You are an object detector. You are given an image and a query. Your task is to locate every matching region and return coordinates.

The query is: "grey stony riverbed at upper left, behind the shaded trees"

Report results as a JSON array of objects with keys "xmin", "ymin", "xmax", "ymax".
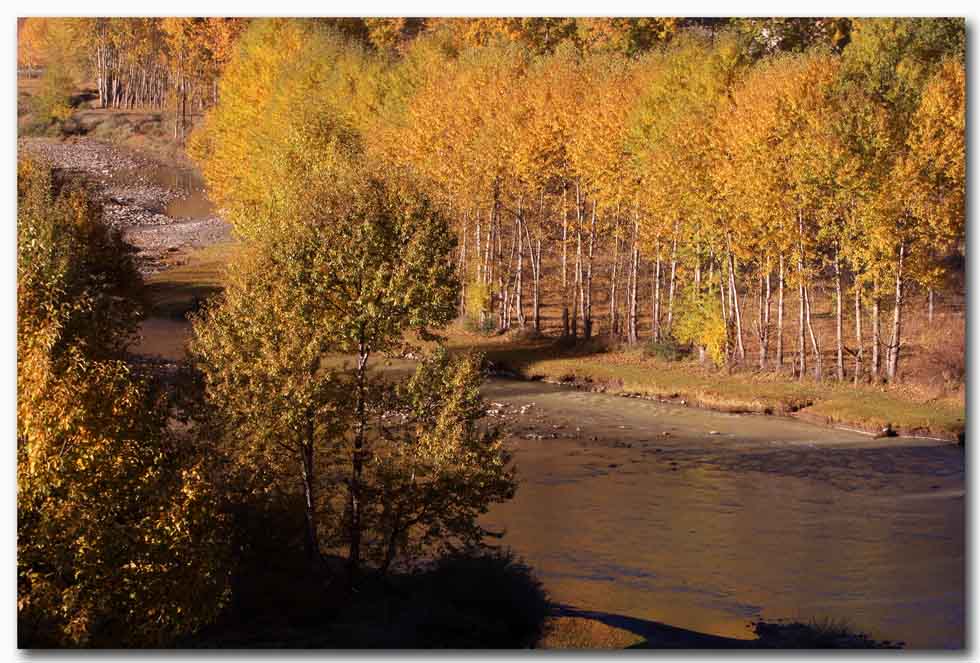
[{"xmin": 18, "ymin": 138, "xmax": 231, "ymax": 277}]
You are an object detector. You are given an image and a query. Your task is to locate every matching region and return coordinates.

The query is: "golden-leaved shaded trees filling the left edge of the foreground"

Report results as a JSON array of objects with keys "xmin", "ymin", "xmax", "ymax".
[{"xmin": 17, "ymin": 161, "xmax": 229, "ymax": 647}]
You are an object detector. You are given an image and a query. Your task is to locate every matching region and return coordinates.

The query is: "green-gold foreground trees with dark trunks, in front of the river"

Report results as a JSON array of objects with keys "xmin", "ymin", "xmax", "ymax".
[{"xmin": 192, "ymin": 166, "xmax": 513, "ymax": 581}]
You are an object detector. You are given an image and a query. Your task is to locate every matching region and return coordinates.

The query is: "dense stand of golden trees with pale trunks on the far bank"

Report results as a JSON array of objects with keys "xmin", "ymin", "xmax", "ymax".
[{"xmin": 188, "ymin": 18, "xmax": 965, "ymax": 381}]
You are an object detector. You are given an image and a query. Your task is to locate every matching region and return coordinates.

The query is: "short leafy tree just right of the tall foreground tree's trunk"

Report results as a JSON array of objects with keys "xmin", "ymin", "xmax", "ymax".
[{"xmin": 363, "ymin": 347, "xmax": 516, "ymax": 572}]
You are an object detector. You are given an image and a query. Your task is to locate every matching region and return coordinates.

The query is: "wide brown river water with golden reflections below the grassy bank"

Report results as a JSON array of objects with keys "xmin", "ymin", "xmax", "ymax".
[{"xmin": 485, "ymin": 381, "xmax": 965, "ymax": 647}]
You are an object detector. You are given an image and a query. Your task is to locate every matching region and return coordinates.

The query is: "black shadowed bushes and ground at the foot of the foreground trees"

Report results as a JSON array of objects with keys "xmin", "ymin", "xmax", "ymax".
[{"xmin": 183, "ymin": 503, "xmax": 550, "ymax": 649}]
